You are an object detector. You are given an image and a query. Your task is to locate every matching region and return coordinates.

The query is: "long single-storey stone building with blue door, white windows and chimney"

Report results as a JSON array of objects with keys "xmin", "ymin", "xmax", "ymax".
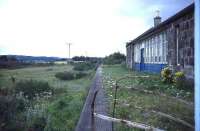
[{"xmin": 126, "ymin": 3, "xmax": 194, "ymax": 79}]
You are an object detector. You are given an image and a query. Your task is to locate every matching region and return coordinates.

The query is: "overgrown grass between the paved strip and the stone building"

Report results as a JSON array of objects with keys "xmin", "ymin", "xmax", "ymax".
[{"xmin": 103, "ymin": 65, "xmax": 194, "ymax": 131}]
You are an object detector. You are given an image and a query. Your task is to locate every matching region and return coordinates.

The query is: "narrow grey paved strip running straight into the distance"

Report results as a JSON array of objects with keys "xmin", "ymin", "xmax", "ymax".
[{"xmin": 75, "ymin": 67, "xmax": 112, "ymax": 131}]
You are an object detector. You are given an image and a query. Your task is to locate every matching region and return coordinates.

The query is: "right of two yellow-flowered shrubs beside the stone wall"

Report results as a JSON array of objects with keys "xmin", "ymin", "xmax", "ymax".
[{"xmin": 173, "ymin": 71, "xmax": 186, "ymax": 88}]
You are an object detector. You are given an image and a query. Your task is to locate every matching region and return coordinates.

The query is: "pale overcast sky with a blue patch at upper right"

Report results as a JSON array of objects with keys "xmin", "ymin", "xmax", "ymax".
[{"xmin": 0, "ymin": 0, "xmax": 193, "ymax": 57}]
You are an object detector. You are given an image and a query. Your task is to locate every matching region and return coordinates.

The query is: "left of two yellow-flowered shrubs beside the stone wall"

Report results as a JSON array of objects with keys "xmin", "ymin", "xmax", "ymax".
[{"xmin": 161, "ymin": 67, "xmax": 173, "ymax": 83}]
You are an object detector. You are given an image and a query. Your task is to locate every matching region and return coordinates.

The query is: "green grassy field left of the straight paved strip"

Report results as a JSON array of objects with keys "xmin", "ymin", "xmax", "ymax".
[{"xmin": 0, "ymin": 65, "xmax": 94, "ymax": 131}]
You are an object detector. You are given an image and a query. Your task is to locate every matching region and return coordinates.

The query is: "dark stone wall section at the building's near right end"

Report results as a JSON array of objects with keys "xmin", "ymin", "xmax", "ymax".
[{"xmin": 167, "ymin": 12, "xmax": 194, "ymax": 79}]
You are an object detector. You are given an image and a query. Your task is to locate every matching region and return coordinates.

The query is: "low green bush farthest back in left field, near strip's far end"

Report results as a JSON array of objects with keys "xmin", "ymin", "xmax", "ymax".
[{"xmin": 73, "ymin": 62, "xmax": 95, "ymax": 71}]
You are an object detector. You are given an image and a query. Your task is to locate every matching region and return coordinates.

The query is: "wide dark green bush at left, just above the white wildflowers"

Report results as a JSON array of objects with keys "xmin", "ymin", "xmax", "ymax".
[{"xmin": 15, "ymin": 80, "xmax": 53, "ymax": 100}]
